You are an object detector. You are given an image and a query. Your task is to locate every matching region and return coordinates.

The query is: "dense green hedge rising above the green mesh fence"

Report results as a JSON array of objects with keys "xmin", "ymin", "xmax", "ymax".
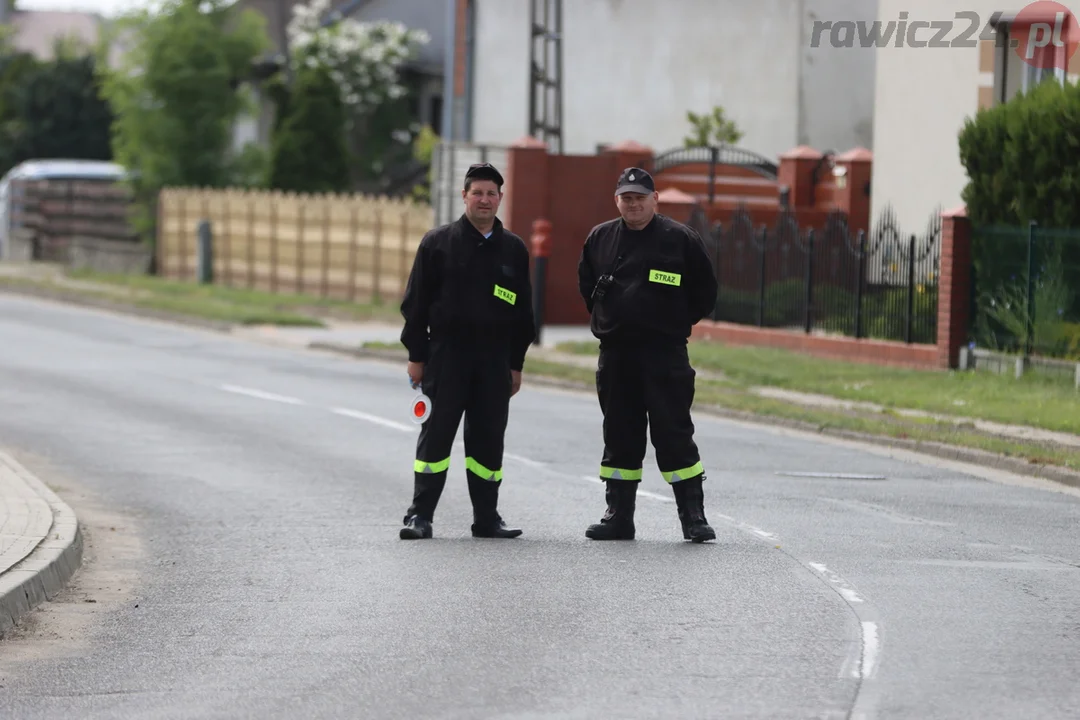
[{"xmin": 959, "ymin": 81, "xmax": 1080, "ymax": 228}]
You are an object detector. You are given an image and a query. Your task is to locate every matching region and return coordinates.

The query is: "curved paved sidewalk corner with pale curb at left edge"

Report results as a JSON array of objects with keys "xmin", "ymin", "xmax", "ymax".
[{"xmin": 0, "ymin": 451, "xmax": 82, "ymax": 633}]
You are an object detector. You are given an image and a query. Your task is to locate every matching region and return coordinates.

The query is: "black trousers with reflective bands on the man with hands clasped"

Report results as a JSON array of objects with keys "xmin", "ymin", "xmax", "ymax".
[{"xmin": 596, "ymin": 340, "xmax": 704, "ymax": 483}]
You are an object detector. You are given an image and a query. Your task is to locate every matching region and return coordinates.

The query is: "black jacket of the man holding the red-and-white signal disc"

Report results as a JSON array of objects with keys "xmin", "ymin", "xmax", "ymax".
[{"xmin": 401, "ymin": 215, "xmax": 536, "ymax": 370}]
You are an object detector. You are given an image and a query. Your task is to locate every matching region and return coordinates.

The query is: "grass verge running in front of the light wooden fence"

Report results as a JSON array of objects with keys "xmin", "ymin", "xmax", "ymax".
[{"xmin": 0, "ymin": 271, "xmax": 399, "ymax": 327}]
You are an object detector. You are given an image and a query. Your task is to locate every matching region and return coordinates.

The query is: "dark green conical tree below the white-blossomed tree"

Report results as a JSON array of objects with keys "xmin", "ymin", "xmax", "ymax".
[{"xmin": 270, "ymin": 66, "xmax": 349, "ymax": 192}]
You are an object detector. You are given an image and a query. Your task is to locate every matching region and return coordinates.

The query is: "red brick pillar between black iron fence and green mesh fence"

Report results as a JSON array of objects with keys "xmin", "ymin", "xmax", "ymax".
[{"xmin": 937, "ymin": 207, "xmax": 971, "ymax": 369}]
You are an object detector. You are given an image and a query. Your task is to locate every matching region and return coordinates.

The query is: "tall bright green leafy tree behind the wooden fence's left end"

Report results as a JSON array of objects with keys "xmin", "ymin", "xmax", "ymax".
[{"xmin": 103, "ymin": 0, "xmax": 269, "ymax": 237}]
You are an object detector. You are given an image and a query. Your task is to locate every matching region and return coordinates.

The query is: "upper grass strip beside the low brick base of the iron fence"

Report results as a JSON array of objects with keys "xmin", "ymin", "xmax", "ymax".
[{"xmin": 558, "ymin": 342, "xmax": 1080, "ymax": 434}]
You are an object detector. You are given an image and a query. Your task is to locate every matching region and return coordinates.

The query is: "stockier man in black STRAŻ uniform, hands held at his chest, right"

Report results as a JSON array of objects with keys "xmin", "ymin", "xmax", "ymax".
[{"xmin": 578, "ymin": 167, "xmax": 717, "ymax": 542}]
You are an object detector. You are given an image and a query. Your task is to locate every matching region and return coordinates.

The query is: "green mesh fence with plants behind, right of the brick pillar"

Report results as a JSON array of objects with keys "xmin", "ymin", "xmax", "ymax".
[{"xmin": 970, "ymin": 223, "xmax": 1080, "ymax": 359}]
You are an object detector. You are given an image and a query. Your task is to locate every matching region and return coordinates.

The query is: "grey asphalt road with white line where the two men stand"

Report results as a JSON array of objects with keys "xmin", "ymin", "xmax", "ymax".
[{"xmin": 0, "ymin": 295, "xmax": 1080, "ymax": 720}]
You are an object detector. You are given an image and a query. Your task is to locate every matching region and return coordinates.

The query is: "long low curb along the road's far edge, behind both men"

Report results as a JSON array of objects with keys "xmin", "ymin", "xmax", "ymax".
[{"xmin": 308, "ymin": 342, "xmax": 1080, "ymax": 488}]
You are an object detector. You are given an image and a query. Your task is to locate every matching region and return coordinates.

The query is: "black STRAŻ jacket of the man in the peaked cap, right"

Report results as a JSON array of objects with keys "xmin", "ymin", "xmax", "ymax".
[{"xmin": 578, "ymin": 214, "xmax": 717, "ymax": 342}]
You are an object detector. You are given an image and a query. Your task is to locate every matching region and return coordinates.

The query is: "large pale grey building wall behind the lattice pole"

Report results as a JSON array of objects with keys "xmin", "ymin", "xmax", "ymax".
[{"xmin": 472, "ymin": 0, "xmax": 807, "ymax": 155}]
